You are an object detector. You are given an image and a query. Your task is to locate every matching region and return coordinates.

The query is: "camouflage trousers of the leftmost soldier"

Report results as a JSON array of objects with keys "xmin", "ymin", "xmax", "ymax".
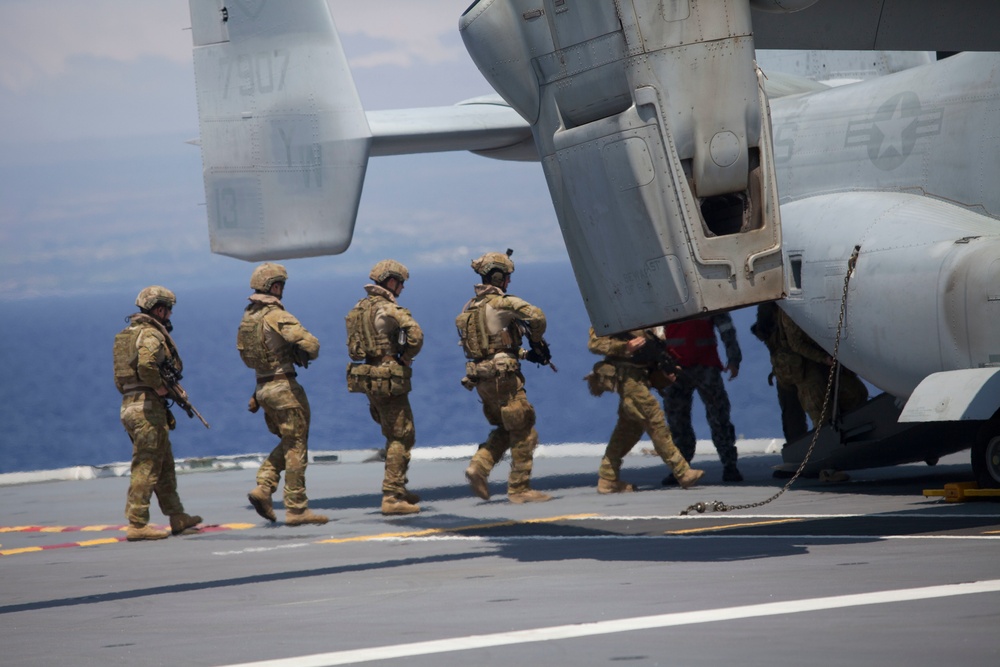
[{"xmin": 121, "ymin": 391, "xmax": 184, "ymax": 526}]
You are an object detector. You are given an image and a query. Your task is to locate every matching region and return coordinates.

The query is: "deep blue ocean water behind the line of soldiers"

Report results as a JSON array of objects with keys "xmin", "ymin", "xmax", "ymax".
[{"xmin": 0, "ymin": 264, "xmax": 781, "ymax": 473}]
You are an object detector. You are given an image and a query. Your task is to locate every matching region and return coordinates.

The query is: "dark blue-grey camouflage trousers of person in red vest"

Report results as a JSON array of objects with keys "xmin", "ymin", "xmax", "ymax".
[{"xmin": 663, "ymin": 366, "xmax": 737, "ymax": 467}]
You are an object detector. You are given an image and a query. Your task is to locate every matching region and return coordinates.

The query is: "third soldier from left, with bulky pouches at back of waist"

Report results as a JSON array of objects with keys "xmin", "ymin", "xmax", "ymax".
[{"xmin": 346, "ymin": 259, "xmax": 424, "ymax": 514}]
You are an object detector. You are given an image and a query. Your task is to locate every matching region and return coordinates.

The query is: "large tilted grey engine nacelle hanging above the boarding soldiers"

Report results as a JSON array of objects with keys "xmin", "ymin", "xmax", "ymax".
[{"xmin": 460, "ymin": 0, "xmax": 785, "ymax": 333}]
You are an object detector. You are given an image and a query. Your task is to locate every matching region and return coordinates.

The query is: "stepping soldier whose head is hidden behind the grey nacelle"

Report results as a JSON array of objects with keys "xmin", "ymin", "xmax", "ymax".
[{"xmin": 587, "ymin": 327, "xmax": 705, "ymax": 493}]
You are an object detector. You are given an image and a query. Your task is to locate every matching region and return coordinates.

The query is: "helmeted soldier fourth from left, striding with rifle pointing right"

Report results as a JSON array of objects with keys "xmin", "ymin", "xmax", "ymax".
[{"xmin": 455, "ymin": 251, "xmax": 551, "ymax": 503}]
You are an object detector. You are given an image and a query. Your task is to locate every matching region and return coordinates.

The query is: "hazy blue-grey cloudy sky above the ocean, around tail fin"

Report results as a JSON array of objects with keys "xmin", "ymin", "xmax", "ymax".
[{"xmin": 0, "ymin": 0, "xmax": 567, "ymax": 300}]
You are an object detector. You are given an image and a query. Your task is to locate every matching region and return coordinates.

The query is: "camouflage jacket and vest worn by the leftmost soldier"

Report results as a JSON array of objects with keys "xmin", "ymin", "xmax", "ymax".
[{"xmin": 115, "ymin": 313, "xmax": 184, "ymax": 394}]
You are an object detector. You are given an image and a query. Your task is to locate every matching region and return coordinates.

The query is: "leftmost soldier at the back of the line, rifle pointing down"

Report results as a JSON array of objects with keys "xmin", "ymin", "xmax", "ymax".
[{"xmin": 114, "ymin": 285, "xmax": 201, "ymax": 542}]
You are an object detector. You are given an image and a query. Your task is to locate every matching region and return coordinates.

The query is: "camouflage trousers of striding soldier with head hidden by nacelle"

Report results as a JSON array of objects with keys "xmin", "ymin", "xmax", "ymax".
[{"xmin": 597, "ymin": 367, "xmax": 689, "ymax": 482}]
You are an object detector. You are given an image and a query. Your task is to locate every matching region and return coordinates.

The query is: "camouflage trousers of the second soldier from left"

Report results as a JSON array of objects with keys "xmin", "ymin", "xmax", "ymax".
[{"xmin": 256, "ymin": 378, "xmax": 310, "ymax": 510}]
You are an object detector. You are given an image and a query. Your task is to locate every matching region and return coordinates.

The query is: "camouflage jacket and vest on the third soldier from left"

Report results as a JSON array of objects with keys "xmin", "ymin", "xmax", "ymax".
[{"xmin": 348, "ymin": 285, "xmax": 424, "ymax": 366}]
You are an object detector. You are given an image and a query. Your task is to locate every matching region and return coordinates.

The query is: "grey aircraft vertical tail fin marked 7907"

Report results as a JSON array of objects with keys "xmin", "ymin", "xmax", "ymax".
[{"xmin": 190, "ymin": 0, "xmax": 371, "ymax": 261}]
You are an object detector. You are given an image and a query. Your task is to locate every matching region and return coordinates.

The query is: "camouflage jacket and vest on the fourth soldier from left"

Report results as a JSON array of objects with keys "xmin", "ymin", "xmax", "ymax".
[{"xmin": 456, "ymin": 284, "xmax": 546, "ymax": 362}]
